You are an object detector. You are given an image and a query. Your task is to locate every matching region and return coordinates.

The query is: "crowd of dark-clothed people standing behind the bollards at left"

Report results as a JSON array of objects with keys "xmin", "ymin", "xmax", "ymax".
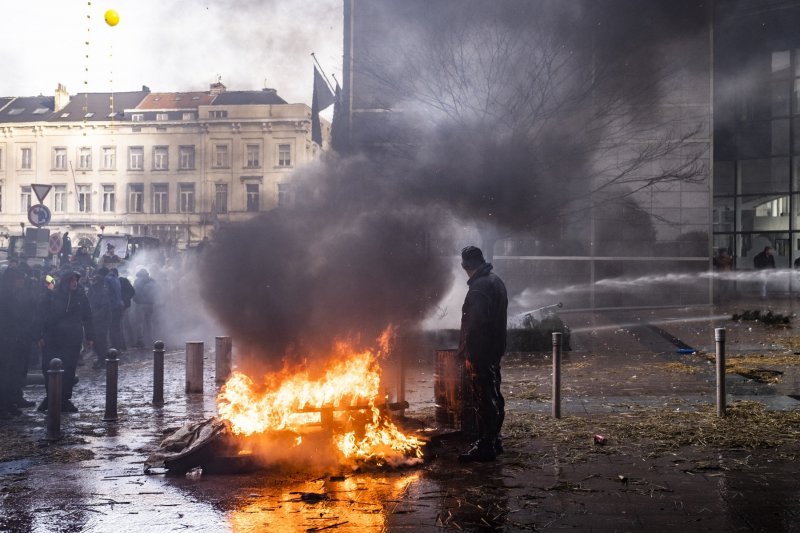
[{"xmin": 0, "ymin": 246, "xmax": 164, "ymax": 418}]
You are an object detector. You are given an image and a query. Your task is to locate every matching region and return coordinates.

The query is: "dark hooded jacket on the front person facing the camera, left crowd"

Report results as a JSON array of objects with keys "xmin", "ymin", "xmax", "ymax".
[{"xmin": 43, "ymin": 273, "xmax": 94, "ymax": 345}]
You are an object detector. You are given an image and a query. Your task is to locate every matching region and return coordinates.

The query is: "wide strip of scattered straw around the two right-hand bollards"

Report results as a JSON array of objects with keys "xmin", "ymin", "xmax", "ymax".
[{"xmin": 503, "ymin": 401, "xmax": 800, "ymax": 462}]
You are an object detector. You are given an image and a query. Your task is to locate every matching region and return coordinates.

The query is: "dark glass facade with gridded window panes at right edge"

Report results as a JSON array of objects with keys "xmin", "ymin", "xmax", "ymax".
[{"xmin": 712, "ymin": 0, "xmax": 800, "ymax": 278}]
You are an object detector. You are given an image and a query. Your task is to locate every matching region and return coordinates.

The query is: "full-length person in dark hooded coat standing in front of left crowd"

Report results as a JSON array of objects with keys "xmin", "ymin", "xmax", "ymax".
[{"xmin": 38, "ymin": 272, "xmax": 94, "ymax": 413}]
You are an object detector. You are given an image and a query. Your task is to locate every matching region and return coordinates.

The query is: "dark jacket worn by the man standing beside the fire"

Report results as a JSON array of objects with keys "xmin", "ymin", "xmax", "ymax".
[{"xmin": 459, "ymin": 263, "xmax": 508, "ymax": 365}]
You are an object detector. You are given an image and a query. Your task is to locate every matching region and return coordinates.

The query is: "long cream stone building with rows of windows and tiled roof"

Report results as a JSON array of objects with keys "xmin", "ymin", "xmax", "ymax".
[{"xmin": 0, "ymin": 82, "xmax": 330, "ymax": 248}]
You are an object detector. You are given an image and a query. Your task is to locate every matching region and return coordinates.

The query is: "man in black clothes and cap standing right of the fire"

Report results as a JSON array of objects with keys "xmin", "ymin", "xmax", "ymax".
[{"xmin": 458, "ymin": 246, "xmax": 508, "ymax": 462}]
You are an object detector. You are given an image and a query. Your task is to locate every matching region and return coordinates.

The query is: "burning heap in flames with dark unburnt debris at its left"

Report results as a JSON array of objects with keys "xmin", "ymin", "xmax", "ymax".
[{"xmin": 146, "ymin": 338, "xmax": 425, "ymax": 472}]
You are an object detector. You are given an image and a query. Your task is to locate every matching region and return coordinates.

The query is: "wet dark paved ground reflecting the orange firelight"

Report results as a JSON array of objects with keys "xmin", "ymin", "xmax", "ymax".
[{"xmin": 0, "ymin": 300, "xmax": 800, "ymax": 532}]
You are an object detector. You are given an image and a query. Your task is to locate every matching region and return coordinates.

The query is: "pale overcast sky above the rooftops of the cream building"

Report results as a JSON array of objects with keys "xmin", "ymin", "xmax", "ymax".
[{"xmin": 0, "ymin": 0, "xmax": 342, "ymax": 105}]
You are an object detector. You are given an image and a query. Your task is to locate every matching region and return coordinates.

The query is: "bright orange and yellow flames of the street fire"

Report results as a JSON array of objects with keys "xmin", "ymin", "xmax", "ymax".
[{"xmin": 217, "ymin": 335, "xmax": 423, "ymax": 464}]
